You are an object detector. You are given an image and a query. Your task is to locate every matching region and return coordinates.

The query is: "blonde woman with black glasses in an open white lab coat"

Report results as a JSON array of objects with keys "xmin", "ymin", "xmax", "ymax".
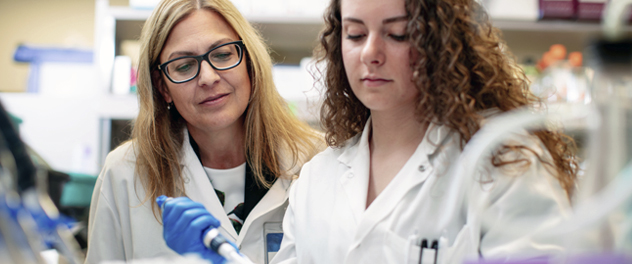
[{"xmin": 86, "ymin": 0, "xmax": 320, "ymax": 263}]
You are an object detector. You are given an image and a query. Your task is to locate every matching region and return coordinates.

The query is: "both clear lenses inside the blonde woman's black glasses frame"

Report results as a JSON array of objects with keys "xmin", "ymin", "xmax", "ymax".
[{"xmin": 166, "ymin": 44, "xmax": 241, "ymax": 82}]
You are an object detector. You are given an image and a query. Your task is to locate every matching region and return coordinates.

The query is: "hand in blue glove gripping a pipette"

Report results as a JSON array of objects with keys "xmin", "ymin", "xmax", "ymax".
[{"xmin": 156, "ymin": 195, "xmax": 237, "ymax": 264}]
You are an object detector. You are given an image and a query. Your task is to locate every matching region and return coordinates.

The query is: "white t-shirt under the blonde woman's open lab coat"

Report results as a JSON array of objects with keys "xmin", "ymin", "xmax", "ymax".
[{"xmin": 204, "ymin": 162, "xmax": 246, "ymax": 214}]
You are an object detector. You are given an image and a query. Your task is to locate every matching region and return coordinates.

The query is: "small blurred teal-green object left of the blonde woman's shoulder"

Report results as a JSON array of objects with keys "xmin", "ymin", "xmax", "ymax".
[{"xmin": 59, "ymin": 173, "xmax": 97, "ymax": 207}]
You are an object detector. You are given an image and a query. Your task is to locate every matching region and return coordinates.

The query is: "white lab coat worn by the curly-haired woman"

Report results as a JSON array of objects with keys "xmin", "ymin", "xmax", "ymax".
[{"xmin": 272, "ymin": 117, "xmax": 570, "ymax": 264}]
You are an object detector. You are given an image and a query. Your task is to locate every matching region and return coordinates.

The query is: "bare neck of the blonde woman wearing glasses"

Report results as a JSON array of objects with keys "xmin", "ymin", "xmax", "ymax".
[{"xmin": 189, "ymin": 122, "xmax": 246, "ymax": 169}]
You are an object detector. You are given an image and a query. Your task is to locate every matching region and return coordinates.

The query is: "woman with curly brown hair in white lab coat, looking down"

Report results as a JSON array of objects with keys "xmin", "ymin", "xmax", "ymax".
[{"xmin": 273, "ymin": 0, "xmax": 577, "ymax": 263}]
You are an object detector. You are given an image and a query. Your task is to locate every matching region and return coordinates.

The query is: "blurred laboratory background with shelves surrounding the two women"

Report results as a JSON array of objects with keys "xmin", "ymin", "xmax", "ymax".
[{"xmin": 0, "ymin": 0, "xmax": 632, "ymax": 263}]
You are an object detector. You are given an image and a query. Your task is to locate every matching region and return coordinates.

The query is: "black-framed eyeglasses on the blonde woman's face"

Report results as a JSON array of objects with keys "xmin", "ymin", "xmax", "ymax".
[{"xmin": 158, "ymin": 40, "xmax": 246, "ymax": 83}]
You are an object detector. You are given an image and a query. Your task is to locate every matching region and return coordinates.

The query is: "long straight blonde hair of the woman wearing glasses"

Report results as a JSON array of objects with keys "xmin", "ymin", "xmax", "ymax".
[{"xmin": 132, "ymin": 0, "xmax": 318, "ymax": 219}]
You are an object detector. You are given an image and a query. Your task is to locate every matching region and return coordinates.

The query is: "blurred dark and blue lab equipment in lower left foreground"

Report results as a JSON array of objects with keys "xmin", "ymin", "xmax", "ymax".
[{"xmin": 0, "ymin": 100, "xmax": 82, "ymax": 264}]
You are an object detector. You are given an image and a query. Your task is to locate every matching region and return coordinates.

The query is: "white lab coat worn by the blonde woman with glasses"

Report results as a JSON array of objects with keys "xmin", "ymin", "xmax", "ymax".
[{"xmin": 86, "ymin": 131, "xmax": 300, "ymax": 263}]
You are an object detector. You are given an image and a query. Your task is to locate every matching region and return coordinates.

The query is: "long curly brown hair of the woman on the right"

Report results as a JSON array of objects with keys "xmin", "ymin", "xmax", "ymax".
[{"xmin": 316, "ymin": 0, "xmax": 578, "ymax": 197}]
